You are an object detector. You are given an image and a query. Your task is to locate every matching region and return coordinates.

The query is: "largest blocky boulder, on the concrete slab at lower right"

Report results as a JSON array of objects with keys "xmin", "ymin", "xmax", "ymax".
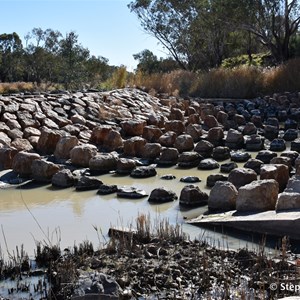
[{"xmin": 236, "ymin": 179, "xmax": 279, "ymax": 212}]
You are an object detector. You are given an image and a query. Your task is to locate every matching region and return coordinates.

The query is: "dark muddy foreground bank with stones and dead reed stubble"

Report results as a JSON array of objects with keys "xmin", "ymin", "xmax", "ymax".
[{"xmin": 0, "ymin": 215, "xmax": 299, "ymax": 299}]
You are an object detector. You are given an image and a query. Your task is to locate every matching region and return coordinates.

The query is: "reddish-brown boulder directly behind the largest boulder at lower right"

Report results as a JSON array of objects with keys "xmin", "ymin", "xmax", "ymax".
[{"xmin": 260, "ymin": 164, "xmax": 289, "ymax": 192}]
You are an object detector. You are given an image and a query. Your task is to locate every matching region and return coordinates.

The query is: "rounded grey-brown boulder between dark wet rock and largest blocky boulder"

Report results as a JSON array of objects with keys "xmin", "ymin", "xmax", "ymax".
[{"xmin": 208, "ymin": 181, "xmax": 238, "ymax": 211}]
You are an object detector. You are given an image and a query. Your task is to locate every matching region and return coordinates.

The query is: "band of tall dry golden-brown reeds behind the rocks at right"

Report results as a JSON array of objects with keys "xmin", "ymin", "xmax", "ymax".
[{"xmin": 129, "ymin": 58, "xmax": 300, "ymax": 98}]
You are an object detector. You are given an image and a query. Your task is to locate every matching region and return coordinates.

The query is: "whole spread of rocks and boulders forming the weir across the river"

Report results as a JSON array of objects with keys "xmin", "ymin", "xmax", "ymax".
[{"xmin": 0, "ymin": 88, "xmax": 300, "ymax": 211}]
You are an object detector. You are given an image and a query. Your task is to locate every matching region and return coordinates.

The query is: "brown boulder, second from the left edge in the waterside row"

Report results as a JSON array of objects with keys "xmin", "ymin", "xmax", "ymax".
[{"xmin": 12, "ymin": 151, "xmax": 41, "ymax": 177}]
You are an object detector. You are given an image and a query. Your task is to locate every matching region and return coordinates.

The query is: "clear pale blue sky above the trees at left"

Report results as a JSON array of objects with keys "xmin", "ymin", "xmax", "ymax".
[{"xmin": 0, "ymin": 0, "xmax": 166, "ymax": 70}]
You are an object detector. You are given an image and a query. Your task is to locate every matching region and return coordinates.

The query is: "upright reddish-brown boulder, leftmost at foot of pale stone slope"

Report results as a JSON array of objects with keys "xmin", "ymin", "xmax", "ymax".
[{"xmin": 37, "ymin": 127, "xmax": 62, "ymax": 154}]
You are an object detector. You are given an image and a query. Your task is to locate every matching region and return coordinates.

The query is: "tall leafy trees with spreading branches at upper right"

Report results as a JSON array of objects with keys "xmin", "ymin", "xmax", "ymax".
[{"xmin": 128, "ymin": 0, "xmax": 300, "ymax": 71}]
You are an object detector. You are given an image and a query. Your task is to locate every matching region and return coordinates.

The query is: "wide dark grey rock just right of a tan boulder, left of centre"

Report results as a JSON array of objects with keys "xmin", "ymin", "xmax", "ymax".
[{"xmin": 89, "ymin": 153, "xmax": 118, "ymax": 173}]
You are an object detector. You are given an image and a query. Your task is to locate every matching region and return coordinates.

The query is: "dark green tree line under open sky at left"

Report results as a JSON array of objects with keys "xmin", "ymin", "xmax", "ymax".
[{"xmin": 0, "ymin": 28, "xmax": 116, "ymax": 89}]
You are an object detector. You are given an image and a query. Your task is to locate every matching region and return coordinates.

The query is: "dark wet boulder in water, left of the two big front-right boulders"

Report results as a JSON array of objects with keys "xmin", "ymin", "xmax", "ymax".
[{"xmin": 179, "ymin": 185, "xmax": 208, "ymax": 207}]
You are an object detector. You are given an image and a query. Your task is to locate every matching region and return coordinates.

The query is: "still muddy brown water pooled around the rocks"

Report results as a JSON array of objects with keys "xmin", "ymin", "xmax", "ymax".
[{"xmin": 0, "ymin": 157, "xmax": 284, "ymax": 255}]
